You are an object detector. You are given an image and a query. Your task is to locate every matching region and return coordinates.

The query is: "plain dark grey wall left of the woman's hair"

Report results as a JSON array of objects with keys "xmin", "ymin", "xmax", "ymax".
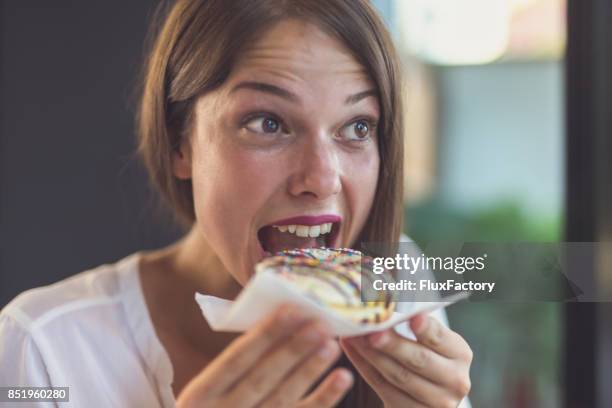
[{"xmin": 0, "ymin": 0, "xmax": 178, "ymax": 308}]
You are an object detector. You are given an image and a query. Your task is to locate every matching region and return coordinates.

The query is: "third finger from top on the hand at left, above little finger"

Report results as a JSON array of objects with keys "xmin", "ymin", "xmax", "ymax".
[{"xmin": 262, "ymin": 340, "xmax": 340, "ymax": 407}]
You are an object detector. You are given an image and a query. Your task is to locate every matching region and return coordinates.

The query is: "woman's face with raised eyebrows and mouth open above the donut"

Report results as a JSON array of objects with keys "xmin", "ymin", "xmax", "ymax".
[{"xmin": 174, "ymin": 20, "xmax": 380, "ymax": 285}]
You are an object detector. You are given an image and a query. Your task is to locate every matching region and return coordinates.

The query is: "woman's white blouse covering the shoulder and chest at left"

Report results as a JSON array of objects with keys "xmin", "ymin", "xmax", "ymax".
[{"xmin": 0, "ymin": 252, "xmax": 469, "ymax": 408}]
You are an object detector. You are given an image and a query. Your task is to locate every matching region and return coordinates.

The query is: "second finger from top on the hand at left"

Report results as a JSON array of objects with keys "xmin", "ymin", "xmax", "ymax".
[{"xmin": 227, "ymin": 322, "xmax": 330, "ymax": 406}]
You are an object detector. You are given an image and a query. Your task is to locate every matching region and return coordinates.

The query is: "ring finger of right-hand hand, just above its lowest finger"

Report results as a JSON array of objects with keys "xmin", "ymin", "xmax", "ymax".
[{"xmin": 351, "ymin": 340, "xmax": 456, "ymax": 407}]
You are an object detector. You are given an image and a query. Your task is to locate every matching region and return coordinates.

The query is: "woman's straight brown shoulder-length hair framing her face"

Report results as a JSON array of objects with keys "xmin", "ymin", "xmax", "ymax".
[{"xmin": 137, "ymin": 0, "xmax": 403, "ymax": 406}]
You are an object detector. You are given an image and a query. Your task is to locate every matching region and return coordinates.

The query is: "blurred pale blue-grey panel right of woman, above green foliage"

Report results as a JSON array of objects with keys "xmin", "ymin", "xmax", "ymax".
[{"xmin": 438, "ymin": 61, "xmax": 565, "ymax": 217}]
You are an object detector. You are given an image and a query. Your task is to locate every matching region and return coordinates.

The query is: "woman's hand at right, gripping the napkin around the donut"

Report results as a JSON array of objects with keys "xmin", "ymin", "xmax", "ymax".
[{"xmin": 340, "ymin": 315, "xmax": 472, "ymax": 408}]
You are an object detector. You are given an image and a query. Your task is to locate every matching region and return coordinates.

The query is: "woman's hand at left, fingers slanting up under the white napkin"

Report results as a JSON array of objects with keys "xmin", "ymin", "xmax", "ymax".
[{"xmin": 177, "ymin": 306, "xmax": 353, "ymax": 408}]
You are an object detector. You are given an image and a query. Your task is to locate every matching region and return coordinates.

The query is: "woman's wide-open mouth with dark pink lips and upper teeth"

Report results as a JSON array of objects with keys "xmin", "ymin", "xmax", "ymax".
[{"xmin": 257, "ymin": 216, "xmax": 340, "ymax": 254}]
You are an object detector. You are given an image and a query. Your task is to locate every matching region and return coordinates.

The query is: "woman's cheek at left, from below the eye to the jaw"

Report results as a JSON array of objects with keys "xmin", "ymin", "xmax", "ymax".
[{"xmin": 192, "ymin": 139, "xmax": 283, "ymax": 284}]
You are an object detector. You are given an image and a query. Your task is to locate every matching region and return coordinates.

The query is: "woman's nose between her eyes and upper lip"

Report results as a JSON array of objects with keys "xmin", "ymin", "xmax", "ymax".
[{"xmin": 289, "ymin": 135, "xmax": 341, "ymax": 200}]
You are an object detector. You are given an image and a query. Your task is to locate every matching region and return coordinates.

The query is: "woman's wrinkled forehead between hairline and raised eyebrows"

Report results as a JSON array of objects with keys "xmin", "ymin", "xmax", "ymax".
[{"xmin": 229, "ymin": 19, "xmax": 373, "ymax": 91}]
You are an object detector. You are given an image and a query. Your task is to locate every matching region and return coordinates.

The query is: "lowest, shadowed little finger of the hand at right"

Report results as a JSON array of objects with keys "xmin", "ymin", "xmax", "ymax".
[{"xmin": 340, "ymin": 339, "xmax": 426, "ymax": 408}]
